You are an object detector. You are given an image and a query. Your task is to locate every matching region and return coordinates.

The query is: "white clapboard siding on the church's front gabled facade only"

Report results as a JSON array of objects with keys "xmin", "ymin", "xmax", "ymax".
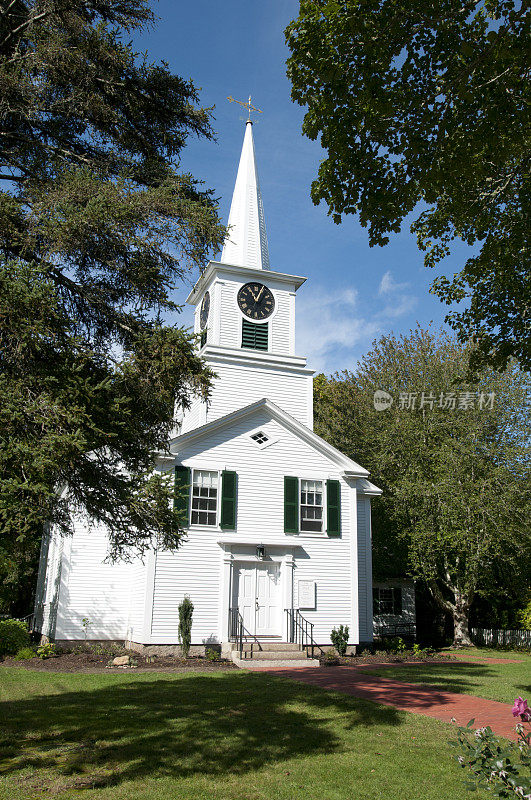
[{"xmin": 166, "ymin": 413, "xmax": 355, "ymax": 644}]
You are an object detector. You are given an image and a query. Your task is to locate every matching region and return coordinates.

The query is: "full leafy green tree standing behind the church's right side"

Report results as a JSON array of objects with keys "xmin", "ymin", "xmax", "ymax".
[{"xmin": 315, "ymin": 330, "xmax": 531, "ymax": 644}]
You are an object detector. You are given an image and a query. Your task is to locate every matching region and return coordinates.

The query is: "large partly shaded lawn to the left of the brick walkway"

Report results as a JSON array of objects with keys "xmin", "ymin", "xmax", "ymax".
[{"xmin": 0, "ymin": 668, "xmax": 483, "ymax": 800}]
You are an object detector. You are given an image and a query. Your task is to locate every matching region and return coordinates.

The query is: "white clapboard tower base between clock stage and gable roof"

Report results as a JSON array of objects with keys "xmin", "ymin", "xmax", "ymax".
[{"xmin": 204, "ymin": 362, "xmax": 311, "ymax": 430}]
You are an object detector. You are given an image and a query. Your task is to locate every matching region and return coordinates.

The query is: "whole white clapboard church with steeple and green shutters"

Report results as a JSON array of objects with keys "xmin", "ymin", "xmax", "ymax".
[{"xmin": 35, "ymin": 121, "xmax": 381, "ymax": 649}]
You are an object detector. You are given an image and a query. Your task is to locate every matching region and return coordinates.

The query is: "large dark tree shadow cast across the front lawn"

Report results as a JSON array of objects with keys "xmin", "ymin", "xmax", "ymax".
[{"xmin": 0, "ymin": 673, "xmax": 404, "ymax": 786}]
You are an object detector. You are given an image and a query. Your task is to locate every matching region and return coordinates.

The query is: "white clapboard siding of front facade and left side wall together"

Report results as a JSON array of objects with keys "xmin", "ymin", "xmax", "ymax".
[{"xmin": 35, "ymin": 411, "xmax": 372, "ymax": 644}]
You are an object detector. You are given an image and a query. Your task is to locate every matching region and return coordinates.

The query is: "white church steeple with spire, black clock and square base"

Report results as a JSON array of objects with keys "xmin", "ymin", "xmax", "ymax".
[{"xmin": 180, "ymin": 119, "xmax": 313, "ymax": 433}]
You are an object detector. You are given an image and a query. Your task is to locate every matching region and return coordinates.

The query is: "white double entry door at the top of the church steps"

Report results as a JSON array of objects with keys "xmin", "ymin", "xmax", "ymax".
[{"xmin": 232, "ymin": 563, "xmax": 282, "ymax": 636}]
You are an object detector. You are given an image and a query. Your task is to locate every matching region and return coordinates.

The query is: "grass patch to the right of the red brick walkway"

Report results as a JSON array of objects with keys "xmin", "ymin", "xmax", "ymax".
[{"xmin": 367, "ymin": 648, "xmax": 531, "ymax": 704}]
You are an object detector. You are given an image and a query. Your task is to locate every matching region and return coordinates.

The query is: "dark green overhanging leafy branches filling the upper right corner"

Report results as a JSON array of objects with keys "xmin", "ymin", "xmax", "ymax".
[{"xmin": 286, "ymin": 0, "xmax": 531, "ymax": 369}]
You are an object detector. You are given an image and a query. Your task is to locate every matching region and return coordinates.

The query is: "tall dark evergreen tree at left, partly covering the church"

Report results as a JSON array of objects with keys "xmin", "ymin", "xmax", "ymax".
[{"xmin": 0, "ymin": 0, "xmax": 224, "ymax": 608}]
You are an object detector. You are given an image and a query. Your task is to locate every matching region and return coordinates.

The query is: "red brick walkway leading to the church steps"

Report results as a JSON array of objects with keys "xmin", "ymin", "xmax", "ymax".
[{"xmin": 265, "ymin": 667, "xmax": 516, "ymax": 739}]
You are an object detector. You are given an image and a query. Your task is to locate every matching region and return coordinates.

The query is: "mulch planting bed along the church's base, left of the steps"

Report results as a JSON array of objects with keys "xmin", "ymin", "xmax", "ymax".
[{"xmin": 0, "ymin": 652, "xmax": 238, "ymax": 673}]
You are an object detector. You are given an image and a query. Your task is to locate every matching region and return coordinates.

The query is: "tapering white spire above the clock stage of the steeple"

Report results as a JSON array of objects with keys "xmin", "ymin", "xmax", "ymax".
[{"xmin": 220, "ymin": 121, "xmax": 269, "ymax": 269}]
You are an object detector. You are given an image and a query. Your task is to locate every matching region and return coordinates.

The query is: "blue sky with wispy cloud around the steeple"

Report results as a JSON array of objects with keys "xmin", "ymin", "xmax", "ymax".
[{"xmin": 134, "ymin": 0, "xmax": 472, "ymax": 373}]
